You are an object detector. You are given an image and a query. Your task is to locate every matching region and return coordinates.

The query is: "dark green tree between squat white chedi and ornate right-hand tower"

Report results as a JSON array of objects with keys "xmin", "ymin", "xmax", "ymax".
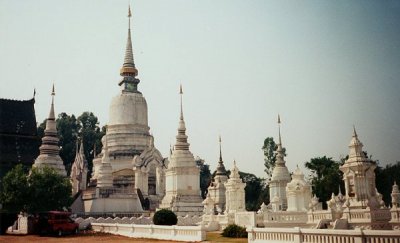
[{"xmin": 305, "ymin": 156, "xmax": 344, "ymax": 209}]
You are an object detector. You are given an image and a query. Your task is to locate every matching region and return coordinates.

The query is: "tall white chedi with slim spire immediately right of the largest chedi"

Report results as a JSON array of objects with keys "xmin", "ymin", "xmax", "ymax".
[{"xmin": 160, "ymin": 86, "xmax": 203, "ymax": 216}]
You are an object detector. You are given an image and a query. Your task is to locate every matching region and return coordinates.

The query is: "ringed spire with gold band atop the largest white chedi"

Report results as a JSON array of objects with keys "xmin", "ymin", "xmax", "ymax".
[{"xmin": 119, "ymin": 6, "xmax": 140, "ymax": 92}]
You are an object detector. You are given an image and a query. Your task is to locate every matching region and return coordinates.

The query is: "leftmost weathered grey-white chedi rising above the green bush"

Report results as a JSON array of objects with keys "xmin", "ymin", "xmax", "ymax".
[{"xmin": 32, "ymin": 85, "xmax": 67, "ymax": 176}]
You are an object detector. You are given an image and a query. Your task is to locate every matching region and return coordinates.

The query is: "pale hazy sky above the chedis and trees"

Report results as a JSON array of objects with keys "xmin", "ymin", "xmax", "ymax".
[{"xmin": 0, "ymin": 0, "xmax": 400, "ymax": 177}]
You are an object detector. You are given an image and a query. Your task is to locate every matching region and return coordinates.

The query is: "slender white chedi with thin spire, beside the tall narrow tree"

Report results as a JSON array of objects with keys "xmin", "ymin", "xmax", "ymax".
[{"xmin": 269, "ymin": 115, "xmax": 291, "ymax": 211}]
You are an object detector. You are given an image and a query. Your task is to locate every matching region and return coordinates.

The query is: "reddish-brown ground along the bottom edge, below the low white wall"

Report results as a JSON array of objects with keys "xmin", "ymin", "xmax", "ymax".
[{"xmin": 0, "ymin": 232, "xmax": 247, "ymax": 243}]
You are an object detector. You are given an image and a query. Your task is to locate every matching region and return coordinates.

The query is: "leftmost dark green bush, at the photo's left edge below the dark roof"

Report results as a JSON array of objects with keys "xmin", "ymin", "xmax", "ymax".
[{"xmin": 0, "ymin": 164, "xmax": 30, "ymax": 212}]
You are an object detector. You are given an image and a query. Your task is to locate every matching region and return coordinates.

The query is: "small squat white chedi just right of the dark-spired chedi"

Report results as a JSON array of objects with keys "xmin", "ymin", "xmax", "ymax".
[{"xmin": 225, "ymin": 161, "xmax": 246, "ymax": 213}]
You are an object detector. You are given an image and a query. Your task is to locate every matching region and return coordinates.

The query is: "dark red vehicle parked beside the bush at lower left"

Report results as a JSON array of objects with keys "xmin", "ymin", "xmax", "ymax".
[{"xmin": 37, "ymin": 211, "xmax": 79, "ymax": 236}]
